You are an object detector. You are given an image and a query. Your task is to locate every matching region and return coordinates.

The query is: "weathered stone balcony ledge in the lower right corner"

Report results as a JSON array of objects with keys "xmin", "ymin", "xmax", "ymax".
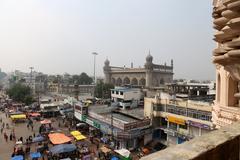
[{"xmin": 141, "ymin": 122, "xmax": 240, "ymax": 160}]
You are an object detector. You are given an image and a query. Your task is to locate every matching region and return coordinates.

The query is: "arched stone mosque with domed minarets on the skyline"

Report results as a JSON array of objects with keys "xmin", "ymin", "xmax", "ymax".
[{"xmin": 103, "ymin": 54, "xmax": 173, "ymax": 88}]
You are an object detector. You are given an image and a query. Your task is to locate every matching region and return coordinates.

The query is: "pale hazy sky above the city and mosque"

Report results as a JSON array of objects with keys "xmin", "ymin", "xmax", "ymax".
[{"xmin": 0, "ymin": 0, "xmax": 215, "ymax": 79}]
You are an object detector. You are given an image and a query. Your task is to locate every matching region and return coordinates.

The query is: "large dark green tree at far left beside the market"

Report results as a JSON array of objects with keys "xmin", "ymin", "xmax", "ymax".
[{"xmin": 7, "ymin": 83, "xmax": 33, "ymax": 105}]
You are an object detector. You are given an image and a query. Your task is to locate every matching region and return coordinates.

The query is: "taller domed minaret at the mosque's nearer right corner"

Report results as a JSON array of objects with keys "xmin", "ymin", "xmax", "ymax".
[{"xmin": 145, "ymin": 53, "xmax": 153, "ymax": 87}]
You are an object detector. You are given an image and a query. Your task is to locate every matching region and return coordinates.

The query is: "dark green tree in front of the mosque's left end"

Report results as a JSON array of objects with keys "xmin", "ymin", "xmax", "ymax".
[{"xmin": 95, "ymin": 82, "xmax": 114, "ymax": 98}]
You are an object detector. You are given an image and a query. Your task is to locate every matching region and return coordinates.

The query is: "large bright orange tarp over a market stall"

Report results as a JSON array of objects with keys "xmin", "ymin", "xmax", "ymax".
[{"xmin": 48, "ymin": 133, "xmax": 71, "ymax": 144}]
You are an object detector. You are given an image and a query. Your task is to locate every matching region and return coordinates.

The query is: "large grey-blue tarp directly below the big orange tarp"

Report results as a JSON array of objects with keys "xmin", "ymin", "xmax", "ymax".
[{"xmin": 50, "ymin": 144, "xmax": 77, "ymax": 154}]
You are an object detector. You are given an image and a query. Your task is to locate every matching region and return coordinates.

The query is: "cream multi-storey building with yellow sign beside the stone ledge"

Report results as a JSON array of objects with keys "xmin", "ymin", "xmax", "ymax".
[{"xmin": 144, "ymin": 94, "xmax": 213, "ymax": 146}]
